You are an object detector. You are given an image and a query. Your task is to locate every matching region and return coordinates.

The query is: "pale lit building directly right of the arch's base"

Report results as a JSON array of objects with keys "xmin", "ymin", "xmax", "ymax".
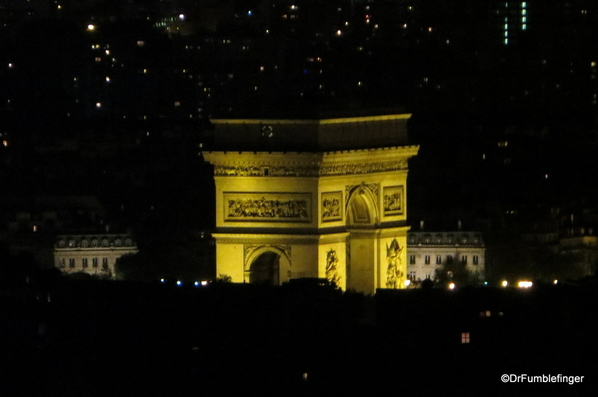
[{"xmin": 407, "ymin": 231, "xmax": 486, "ymax": 284}]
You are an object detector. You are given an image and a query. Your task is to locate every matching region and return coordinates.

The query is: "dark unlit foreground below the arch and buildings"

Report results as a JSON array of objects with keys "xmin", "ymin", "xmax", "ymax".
[{"xmin": 0, "ymin": 280, "xmax": 598, "ymax": 396}]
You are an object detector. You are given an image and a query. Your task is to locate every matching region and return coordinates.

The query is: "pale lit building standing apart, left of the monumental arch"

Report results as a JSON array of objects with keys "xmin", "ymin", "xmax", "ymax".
[{"xmin": 54, "ymin": 234, "xmax": 137, "ymax": 277}]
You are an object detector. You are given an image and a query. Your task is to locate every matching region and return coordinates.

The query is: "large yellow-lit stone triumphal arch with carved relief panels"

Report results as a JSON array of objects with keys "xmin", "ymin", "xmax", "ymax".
[{"xmin": 203, "ymin": 114, "xmax": 418, "ymax": 293}]
